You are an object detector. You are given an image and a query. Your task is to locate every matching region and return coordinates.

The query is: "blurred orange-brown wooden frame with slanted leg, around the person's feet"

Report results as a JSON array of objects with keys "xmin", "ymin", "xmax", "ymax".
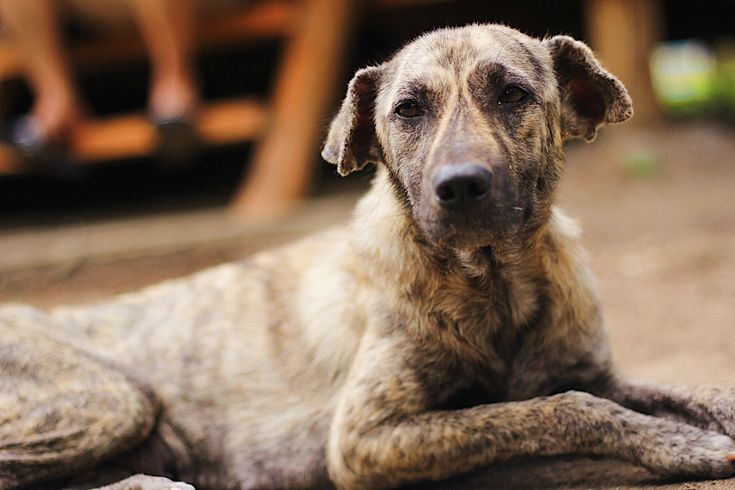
[{"xmin": 0, "ymin": 0, "xmax": 355, "ymax": 213}]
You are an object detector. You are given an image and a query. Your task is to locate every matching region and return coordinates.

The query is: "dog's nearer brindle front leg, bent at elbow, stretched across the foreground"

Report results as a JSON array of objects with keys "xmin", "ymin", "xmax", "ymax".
[{"xmin": 327, "ymin": 334, "xmax": 735, "ymax": 488}]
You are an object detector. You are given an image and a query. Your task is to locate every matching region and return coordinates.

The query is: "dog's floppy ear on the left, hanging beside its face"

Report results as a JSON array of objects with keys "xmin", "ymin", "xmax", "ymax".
[{"xmin": 322, "ymin": 66, "xmax": 383, "ymax": 176}]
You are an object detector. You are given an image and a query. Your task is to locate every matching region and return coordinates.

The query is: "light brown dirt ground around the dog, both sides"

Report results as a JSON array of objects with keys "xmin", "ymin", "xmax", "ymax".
[{"xmin": 0, "ymin": 123, "xmax": 735, "ymax": 489}]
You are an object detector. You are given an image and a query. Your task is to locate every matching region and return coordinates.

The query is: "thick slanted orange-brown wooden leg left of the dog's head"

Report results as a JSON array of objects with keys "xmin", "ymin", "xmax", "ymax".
[{"xmin": 232, "ymin": 0, "xmax": 358, "ymax": 221}]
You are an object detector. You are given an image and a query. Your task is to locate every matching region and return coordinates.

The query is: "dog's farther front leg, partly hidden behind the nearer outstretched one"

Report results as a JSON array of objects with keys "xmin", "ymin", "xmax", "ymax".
[{"xmin": 590, "ymin": 377, "xmax": 735, "ymax": 438}]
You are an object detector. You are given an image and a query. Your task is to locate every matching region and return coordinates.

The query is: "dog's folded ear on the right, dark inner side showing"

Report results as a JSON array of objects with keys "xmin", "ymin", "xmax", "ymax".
[{"xmin": 544, "ymin": 36, "xmax": 633, "ymax": 141}]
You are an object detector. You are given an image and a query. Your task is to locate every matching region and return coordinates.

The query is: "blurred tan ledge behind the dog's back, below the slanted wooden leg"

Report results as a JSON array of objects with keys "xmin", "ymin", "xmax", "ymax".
[{"xmin": 0, "ymin": 194, "xmax": 358, "ymax": 304}]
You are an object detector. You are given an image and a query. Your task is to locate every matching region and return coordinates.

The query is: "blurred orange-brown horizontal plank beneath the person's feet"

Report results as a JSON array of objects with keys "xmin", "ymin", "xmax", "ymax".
[{"xmin": 0, "ymin": 98, "xmax": 266, "ymax": 174}]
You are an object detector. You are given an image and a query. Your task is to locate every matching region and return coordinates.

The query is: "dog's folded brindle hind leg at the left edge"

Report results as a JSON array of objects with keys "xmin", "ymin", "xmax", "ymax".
[{"xmin": 0, "ymin": 307, "xmax": 158, "ymax": 489}]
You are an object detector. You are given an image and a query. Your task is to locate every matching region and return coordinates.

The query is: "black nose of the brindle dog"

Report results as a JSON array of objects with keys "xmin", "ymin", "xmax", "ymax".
[{"xmin": 434, "ymin": 163, "xmax": 492, "ymax": 207}]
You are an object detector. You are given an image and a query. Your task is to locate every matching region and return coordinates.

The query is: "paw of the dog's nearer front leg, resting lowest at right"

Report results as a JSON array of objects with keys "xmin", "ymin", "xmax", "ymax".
[{"xmin": 641, "ymin": 425, "xmax": 735, "ymax": 478}]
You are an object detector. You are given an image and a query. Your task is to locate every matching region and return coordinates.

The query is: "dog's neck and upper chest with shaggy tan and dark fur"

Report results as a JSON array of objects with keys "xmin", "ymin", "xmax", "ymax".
[{"xmin": 351, "ymin": 168, "xmax": 594, "ymax": 367}]
